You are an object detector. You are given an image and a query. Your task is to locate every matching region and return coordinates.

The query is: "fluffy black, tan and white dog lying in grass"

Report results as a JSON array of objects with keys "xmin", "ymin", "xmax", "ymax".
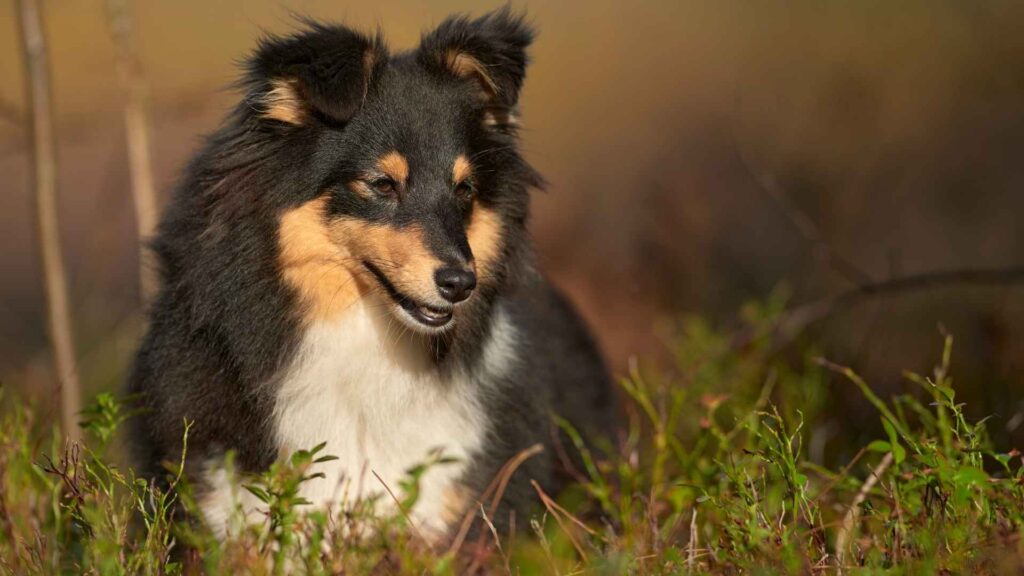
[{"xmin": 128, "ymin": 8, "xmax": 615, "ymax": 540}]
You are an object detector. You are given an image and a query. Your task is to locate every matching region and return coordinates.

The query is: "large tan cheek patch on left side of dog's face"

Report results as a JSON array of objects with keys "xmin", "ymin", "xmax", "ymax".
[{"xmin": 278, "ymin": 196, "xmax": 364, "ymax": 322}]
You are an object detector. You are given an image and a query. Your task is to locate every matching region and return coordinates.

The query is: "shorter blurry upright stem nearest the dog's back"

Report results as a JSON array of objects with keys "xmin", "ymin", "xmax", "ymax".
[{"xmin": 108, "ymin": 0, "xmax": 158, "ymax": 304}]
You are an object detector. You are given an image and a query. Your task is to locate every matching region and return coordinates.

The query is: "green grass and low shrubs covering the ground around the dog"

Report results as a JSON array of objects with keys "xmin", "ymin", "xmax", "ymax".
[{"xmin": 0, "ymin": 293, "xmax": 1024, "ymax": 574}]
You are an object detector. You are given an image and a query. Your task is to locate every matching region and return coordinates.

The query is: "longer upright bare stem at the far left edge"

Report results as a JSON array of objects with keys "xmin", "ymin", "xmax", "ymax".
[{"xmin": 18, "ymin": 0, "xmax": 81, "ymax": 442}]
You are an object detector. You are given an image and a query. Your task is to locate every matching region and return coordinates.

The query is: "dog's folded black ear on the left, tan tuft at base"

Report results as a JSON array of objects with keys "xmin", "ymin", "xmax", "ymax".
[{"xmin": 244, "ymin": 22, "xmax": 388, "ymax": 125}]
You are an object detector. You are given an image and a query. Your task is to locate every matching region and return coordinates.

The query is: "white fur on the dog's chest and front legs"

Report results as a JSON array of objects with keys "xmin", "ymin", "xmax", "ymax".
[{"xmin": 203, "ymin": 297, "xmax": 515, "ymax": 533}]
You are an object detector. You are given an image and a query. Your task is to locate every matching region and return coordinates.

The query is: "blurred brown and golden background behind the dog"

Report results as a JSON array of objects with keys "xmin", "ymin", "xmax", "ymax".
[{"xmin": 0, "ymin": 0, "xmax": 1024, "ymax": 453}]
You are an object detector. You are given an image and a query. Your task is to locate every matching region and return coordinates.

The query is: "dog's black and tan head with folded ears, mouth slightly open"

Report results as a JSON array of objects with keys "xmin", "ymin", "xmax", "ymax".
[{"xmin": 246, "ymin": 9, "xmax": 538, "ymax": 333}]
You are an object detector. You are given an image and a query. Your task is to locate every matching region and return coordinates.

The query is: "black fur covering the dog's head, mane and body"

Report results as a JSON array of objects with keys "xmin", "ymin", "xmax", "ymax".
[{"xmin": 123, "ymin": 9, "xmax": 613, "ymax": 537}]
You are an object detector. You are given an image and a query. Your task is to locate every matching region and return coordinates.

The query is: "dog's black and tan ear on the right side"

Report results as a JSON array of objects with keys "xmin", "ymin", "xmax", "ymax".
[{"xmin": 417, "ymin": 6, "xmax": 534, "ymax": 125}]
